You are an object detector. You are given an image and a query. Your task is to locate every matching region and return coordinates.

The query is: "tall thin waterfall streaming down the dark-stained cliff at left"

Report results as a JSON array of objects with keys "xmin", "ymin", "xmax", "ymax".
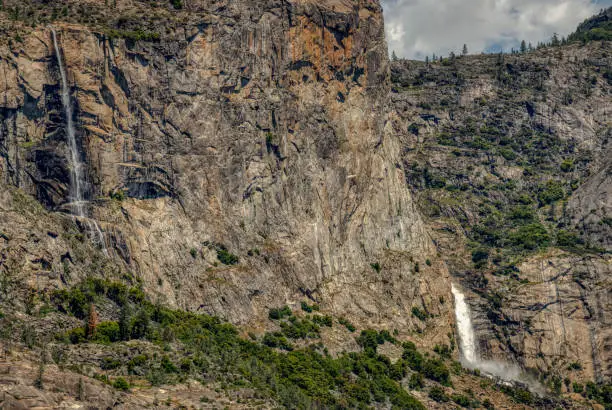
[{"xmin": 51, "ymin": 28, "xmax": 108, "ymax": 256}]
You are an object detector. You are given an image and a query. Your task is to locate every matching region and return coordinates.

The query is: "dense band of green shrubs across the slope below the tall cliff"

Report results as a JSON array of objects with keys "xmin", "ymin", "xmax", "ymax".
[{"xmin": 51, "ymin": 279, "xmax": 430, "ymax": 409}]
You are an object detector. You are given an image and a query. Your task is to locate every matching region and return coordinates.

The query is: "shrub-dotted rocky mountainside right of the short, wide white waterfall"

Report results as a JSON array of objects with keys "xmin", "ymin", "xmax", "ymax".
[{"xmin": 391, "ymin": 42, "xmax": 612, "ymax": 381}]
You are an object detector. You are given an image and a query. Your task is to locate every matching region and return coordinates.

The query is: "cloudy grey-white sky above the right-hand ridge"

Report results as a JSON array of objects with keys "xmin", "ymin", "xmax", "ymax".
[{"xmin": 382, "ymin": 0, "xmax": 612, "ymax": 59}]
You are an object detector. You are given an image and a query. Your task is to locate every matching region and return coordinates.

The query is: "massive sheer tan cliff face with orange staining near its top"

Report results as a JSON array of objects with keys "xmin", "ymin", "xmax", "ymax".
[{"xmin": 0, "ymin": 0, "xmax": 452, "ymax": 340}]
